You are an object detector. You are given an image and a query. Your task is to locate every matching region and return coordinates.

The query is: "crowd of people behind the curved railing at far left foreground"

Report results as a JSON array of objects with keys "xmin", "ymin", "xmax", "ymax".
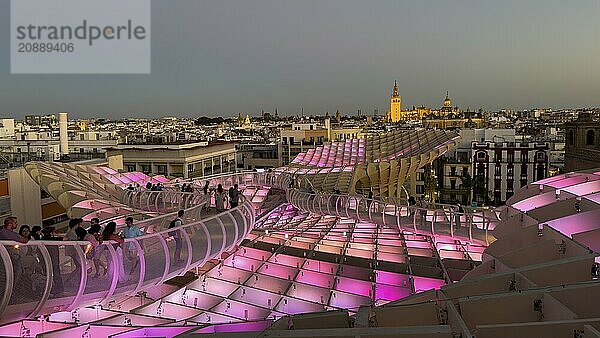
[{"xmin": 0, "ymin": 216, "xmax": 149, "ymax": 296}]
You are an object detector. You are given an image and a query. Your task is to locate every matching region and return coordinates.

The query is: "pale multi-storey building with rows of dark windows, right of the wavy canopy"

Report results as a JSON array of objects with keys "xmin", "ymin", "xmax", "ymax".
[{"xmin": 434, "ymin": 129, "xmax": 550, "ymax": 205}]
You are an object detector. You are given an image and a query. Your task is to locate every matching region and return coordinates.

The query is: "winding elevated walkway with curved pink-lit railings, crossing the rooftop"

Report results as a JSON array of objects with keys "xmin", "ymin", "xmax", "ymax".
[{"xmin": 0, "ymin": 172, "xmax": 495, "ymax": 323}]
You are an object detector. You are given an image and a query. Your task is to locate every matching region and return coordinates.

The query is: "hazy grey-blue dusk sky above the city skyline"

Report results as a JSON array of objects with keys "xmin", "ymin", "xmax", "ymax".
[{"xmin": 0, "ymin": 0, "xmax": 600, "ymax": 118}]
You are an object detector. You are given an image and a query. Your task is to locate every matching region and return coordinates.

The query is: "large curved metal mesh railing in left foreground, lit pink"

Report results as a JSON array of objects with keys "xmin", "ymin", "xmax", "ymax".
[{"xmin": 0, "ymin": 197, "xmax": 255, "ymax": 323}]
